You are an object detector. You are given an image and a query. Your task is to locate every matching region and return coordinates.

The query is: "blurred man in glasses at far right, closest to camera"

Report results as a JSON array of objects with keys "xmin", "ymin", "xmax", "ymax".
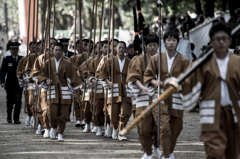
[{"xmin": 166, "ymin": 22, "xmax": 240, "ymax": 159}]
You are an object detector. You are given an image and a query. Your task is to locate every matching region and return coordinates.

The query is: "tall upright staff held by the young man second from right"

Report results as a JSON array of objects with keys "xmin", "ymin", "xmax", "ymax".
[{"xmin": 157, "ymin": 0, "xmax": 163, "ymax": 147}]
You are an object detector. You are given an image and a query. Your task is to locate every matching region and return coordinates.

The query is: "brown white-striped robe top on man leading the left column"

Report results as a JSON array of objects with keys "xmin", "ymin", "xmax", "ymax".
[{"xmin": 38, "ymin": 58, "xmax": 81, "ymax": 104}]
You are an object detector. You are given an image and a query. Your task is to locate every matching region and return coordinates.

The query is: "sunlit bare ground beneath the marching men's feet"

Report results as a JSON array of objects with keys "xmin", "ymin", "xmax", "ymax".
[{"xmin": 0, "ymin": 89, "xmax": 208, "ymax": 159}]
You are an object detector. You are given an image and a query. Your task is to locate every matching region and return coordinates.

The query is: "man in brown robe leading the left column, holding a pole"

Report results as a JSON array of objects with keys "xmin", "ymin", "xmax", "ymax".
[{"xmin": 38, "ymin": 43, "xmax": 81, "ymax": 141}]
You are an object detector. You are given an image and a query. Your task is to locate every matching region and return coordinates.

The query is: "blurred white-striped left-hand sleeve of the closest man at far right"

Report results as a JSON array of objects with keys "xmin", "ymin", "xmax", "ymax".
[{"xmin": 181, "ymin": 63, "xmax": 204, "ymax": 111}]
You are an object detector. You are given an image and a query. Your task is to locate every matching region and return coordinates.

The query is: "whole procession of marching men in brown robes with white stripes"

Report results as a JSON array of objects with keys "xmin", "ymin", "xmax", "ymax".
[{"xmin": 5, "ymin": 23, "xmax": 240, "ymax": 159}]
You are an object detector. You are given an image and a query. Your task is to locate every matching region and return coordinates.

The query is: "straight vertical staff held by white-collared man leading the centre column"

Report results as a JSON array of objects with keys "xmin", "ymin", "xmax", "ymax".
[{"xmin": 111, "ymin": 0, "xmax": 114, "ymax": 122}]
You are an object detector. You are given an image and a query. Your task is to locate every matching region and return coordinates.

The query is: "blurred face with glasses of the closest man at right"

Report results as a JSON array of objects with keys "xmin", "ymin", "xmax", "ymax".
[{"xmin": 210, "ymin": 31, "xmax": 232, "ymax": 53}]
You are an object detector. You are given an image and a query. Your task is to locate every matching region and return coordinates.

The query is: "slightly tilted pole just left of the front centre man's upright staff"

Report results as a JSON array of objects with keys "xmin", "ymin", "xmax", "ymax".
[{"xmin": 105, "ymin": 0, "xmax": 112, "ymax": 127}]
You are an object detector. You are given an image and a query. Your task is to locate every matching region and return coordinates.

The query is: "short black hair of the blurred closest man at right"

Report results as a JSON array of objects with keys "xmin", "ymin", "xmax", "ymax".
[{"xmin": 209, "ymin": 22, "xmax": 232, "ymax": 39}]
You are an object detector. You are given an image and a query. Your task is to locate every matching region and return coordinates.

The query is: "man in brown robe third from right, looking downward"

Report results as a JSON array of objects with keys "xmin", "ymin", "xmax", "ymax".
[{"xmin": 127, "ymin": 34, "xmax": 162, "ymax": 159}]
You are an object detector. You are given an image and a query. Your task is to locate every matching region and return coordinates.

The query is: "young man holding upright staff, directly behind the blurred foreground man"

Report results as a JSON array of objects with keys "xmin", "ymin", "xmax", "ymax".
[{"xmin": 144, "ymin": 31, "xmax": 189, "ymax": 159}]
